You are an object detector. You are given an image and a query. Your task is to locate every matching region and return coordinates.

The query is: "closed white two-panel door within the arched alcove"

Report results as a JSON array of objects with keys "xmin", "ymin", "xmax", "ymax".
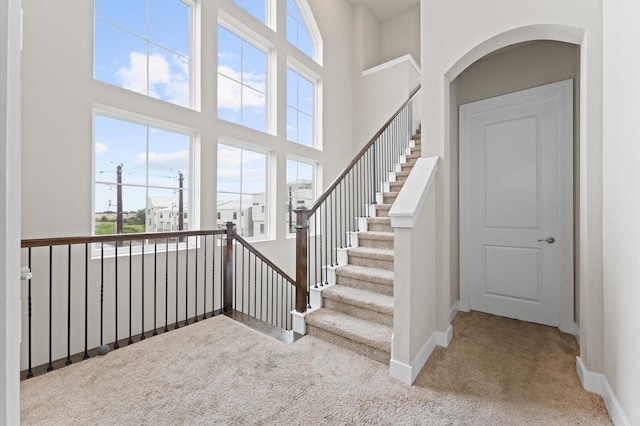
[{"xmin": 460, "ymin": 80, "xmax": 573, "ymax": 331}]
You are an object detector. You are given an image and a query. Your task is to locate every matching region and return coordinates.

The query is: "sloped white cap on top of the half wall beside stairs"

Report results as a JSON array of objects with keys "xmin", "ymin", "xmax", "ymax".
[{"xmin": 389, "ymin": 157, "xmax": 438, "ymax": 228}]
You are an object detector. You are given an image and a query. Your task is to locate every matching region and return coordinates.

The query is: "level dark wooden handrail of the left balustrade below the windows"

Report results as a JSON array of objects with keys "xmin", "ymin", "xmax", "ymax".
[{"xmin": 20, "ymin": 229, "xmax": 226, "ymax": 248}]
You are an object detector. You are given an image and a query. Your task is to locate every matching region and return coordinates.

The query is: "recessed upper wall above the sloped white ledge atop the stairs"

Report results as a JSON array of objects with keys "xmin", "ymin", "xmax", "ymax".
[{"xmin": 378, "ymin": 5, "xmax": 420, "ymax": 65}]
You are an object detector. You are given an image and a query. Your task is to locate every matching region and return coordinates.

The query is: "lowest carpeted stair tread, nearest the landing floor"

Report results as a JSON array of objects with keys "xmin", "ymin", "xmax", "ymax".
[{"xmin": 306, "ymin": 308, "xmax": 393, "ymax": 354}]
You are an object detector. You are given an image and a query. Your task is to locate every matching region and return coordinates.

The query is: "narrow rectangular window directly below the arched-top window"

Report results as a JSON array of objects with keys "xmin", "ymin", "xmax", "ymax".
[{"xmin": 287, "ymin": 68, "xmax": 315, "ymax": 146}]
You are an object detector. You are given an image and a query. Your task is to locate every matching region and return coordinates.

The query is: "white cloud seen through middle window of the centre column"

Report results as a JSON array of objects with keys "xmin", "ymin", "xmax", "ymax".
[{"xmin": 218, "ymin": 65, "xmax": 266, "ymax": 110}]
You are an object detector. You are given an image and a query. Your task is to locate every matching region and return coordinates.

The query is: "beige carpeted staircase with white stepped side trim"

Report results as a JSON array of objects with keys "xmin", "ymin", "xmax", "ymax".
[{"xmin": 305, "ymin": 129, "xmax": 421, "ymax": 363}]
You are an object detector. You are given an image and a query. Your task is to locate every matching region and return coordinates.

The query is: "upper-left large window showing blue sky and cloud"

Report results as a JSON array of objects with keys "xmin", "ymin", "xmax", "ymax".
[{"xmin": 94, "ymin": 0, "xmax": 192, "ymax": 107}]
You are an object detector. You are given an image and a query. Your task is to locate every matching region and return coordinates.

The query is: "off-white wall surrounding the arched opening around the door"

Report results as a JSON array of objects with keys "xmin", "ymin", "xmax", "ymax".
[{"xmin": 421, "ymin": 0, "xmax": 604, "ymax": 380}]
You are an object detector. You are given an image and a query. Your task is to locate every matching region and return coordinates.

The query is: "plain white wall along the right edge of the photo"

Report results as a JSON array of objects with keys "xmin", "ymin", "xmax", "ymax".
[{"xmin": 603, "ymin": 0, "xmax": 640, "ymax": 425}]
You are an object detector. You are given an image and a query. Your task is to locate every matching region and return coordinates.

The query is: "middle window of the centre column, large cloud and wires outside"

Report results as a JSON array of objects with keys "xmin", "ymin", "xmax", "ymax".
[{"xmin": 218, "ymin": 25, "xmax": 267, "ymax": 132}]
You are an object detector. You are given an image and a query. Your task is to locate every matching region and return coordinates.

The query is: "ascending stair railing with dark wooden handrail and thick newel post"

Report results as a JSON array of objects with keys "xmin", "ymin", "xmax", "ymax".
[{"xmin": 295, "ymin": 87, "xmax": 420, "ymax": 313}]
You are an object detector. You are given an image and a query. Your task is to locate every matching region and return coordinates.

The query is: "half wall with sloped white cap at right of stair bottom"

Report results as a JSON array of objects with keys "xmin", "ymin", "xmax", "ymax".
[{"xmin": 389, "ymin": 157, "xmax": 442, "ymax": 384}]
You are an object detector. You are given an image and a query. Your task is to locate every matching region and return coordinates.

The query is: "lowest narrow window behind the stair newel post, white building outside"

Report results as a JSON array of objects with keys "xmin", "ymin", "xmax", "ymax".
[{"xmin": 285, "ymin": 160, "xmax": 315, "ymax": 233}]
